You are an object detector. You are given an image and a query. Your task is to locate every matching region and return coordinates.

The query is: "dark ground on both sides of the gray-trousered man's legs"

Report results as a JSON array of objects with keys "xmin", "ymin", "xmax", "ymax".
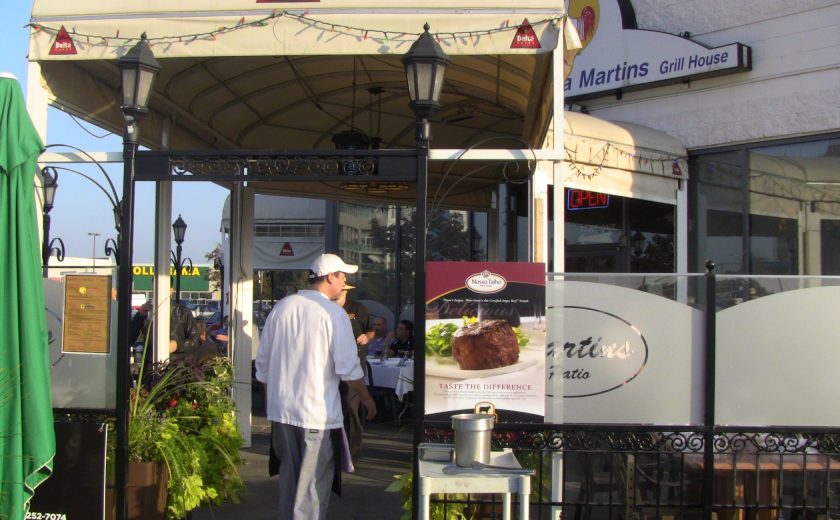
[{"xmin": 192, "ymin": 416, "xmax": 412, "ymax": 520}]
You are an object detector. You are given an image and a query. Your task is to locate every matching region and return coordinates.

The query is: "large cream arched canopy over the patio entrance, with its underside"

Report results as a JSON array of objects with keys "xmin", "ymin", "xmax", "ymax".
[{"xmin": 29, "ymin": 0, "xmax": 574, "ymax": 208}]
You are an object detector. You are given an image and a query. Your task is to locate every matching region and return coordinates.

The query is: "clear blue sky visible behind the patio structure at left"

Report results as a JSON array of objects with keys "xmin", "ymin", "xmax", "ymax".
[{"xmin": 0, "ymin": 0, "xmax": 227, "ymax": 263}]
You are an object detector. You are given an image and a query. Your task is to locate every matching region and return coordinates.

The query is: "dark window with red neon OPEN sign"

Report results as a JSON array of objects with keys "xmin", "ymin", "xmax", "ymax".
[{"xmin": 564, "ymin": 188, "xmax": 676, "ymax": 273}]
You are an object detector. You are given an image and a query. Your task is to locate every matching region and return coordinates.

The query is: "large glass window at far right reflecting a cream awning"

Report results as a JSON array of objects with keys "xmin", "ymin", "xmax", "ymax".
[{"xmin": 689, "ymin": 137, "xmax": 840, "ymax": 275}]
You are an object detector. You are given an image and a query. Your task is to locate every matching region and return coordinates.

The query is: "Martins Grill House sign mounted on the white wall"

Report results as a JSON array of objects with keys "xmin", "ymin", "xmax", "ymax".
[{"xmin": 564, "ymin": 0, "xmax": 752, "ymax": 102}]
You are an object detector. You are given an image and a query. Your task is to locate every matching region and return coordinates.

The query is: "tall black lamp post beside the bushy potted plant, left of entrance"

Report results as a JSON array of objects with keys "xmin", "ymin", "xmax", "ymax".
[{"xmin": 115, "ymin": 33, "xmax": 160, "ymax": 520}]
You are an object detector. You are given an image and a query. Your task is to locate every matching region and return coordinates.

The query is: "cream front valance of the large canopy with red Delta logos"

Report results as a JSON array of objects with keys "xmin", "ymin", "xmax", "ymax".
[{"xmin": 30, "ymin": 0, "xmax": 563, "ymax": 61}]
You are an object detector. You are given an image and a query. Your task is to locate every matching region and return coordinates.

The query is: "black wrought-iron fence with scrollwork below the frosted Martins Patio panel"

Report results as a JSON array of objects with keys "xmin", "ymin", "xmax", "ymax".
[{"xmin": 426, "ymin": 425, "xmax": 840, "ymax": 520}]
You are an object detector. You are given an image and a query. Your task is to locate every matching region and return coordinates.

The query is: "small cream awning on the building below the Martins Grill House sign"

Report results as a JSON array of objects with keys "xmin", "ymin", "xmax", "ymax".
[{"xmin": 555, "ymin": 112, "xmax": 688, "ymax": 204}]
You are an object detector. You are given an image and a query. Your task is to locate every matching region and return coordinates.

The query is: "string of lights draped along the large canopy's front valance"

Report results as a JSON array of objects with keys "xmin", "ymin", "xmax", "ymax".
[{"xmin": 27, "ymin": 9, "xmax": 558, "ymax": 45}]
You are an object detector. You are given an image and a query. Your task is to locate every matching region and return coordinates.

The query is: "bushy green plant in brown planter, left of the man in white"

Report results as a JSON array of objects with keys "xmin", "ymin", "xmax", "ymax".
[{"xmin": 128, "ymin": 357, "xmax": 243, "ymax": 518}]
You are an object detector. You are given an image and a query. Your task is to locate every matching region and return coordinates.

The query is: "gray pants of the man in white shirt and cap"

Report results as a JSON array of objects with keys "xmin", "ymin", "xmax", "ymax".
[{"xmin": 271, "ymin": 422, "xmax": 335, "ymax": 520}]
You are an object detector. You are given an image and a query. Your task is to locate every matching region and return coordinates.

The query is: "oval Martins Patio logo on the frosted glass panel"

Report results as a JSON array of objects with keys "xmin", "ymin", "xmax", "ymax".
[{"xmin": 546, "ymin": 306, "xmax": 648, "ymax": 397}]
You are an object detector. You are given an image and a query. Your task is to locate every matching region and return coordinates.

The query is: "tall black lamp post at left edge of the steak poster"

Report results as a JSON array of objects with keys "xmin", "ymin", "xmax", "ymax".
[{"xmin": 402, "ymin": 23, "xmax": 452, "ymax": 517}]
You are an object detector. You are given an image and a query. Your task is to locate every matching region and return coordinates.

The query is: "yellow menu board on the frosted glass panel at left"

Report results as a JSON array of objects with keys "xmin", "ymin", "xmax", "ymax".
[{"xmin": 61, "ymin": 274, "xmax": 111, "ymax": 354}]
